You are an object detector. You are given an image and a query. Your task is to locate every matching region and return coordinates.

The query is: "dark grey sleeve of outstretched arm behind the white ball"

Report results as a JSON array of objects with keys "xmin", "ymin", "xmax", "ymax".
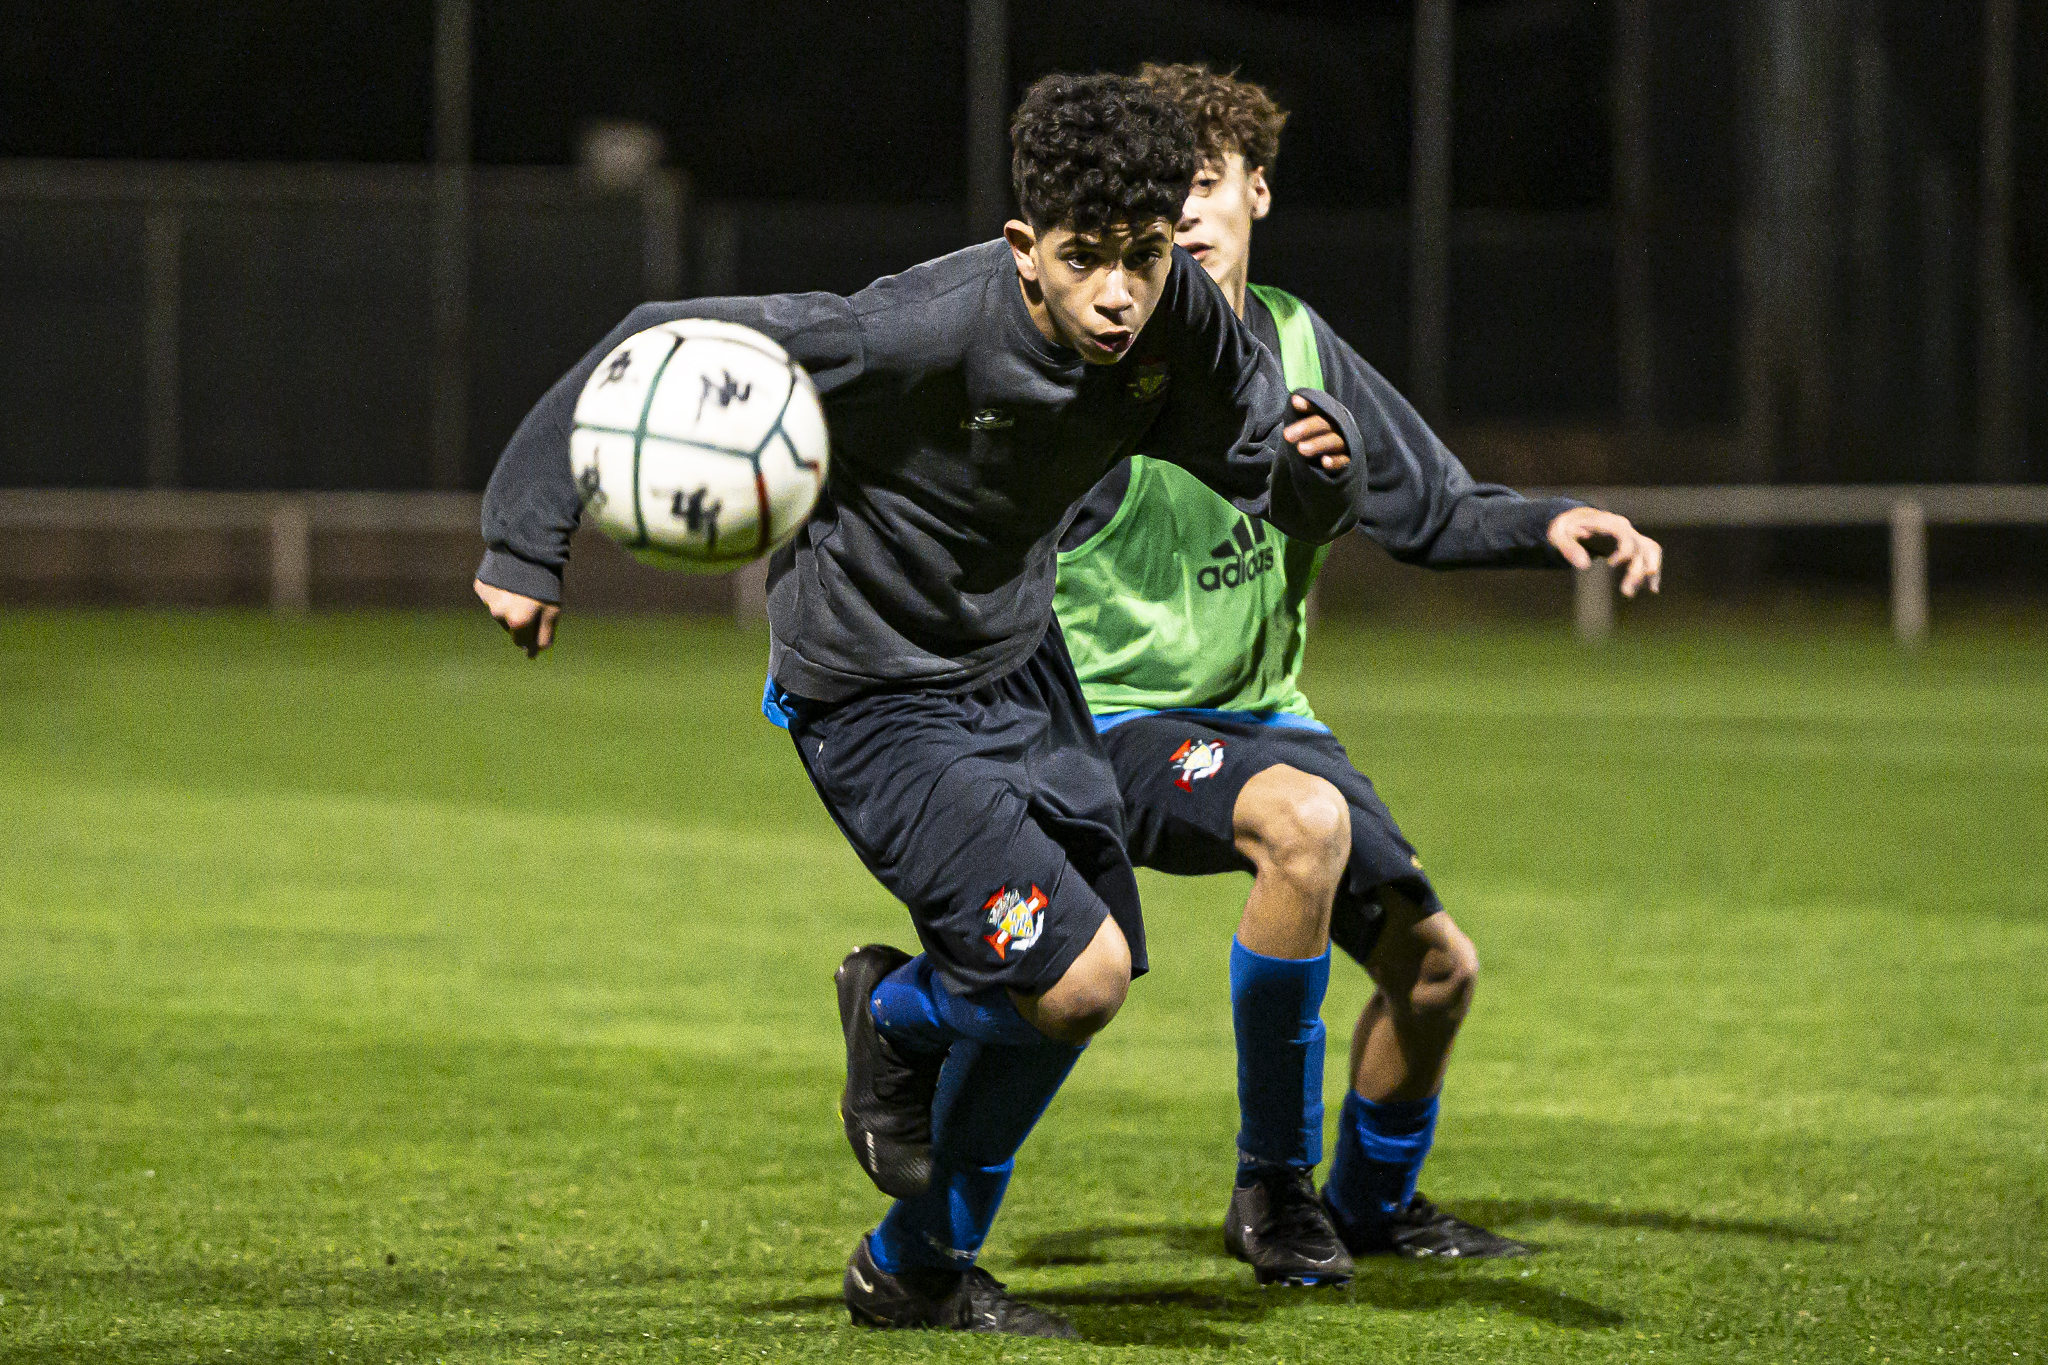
[{"xmin": 477, "ymin": 295, "xmax": 864, "ymax": 602}]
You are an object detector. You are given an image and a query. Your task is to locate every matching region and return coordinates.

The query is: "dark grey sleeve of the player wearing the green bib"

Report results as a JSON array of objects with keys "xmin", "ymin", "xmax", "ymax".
[{"xmin": 1311, "ymin": 313, "xmax": 1579, "ymax": 569}]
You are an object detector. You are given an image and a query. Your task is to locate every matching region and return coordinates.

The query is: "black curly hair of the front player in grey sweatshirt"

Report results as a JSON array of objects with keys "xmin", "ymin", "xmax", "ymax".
[{"xmin": 1010, "ymin": 76, "xmax": 1196, "ymax": 231}]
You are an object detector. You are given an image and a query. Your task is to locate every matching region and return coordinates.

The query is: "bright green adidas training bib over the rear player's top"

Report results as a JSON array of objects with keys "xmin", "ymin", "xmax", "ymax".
[{"xmin": 1053, "ymin": 284, "xmax": 1327, "ymax": 718}]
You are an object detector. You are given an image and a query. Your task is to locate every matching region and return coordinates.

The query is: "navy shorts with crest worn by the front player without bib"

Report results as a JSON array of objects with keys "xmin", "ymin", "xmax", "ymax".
[{"xmin": 780, "ymin": 626, "xmax": 1145, "ymax": 995}]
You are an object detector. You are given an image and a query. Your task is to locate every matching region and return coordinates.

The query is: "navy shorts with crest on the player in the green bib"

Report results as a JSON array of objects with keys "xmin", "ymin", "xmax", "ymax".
[{"xmin": 1102, "ymin": 712, "xmax": 1444, "ymax": 964}]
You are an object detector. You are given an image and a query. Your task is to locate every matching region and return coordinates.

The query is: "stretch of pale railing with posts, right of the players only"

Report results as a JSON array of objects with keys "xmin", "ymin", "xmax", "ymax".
[{"xmin": 1550, "ymin": 483, "xmax": 2048, "ymax": 645}]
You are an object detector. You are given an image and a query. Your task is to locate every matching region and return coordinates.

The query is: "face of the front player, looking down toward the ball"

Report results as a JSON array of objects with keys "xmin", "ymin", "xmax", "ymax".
[{"xmin": 1004, "ymin": 219, "xmax": 1174, "ymax": 364}]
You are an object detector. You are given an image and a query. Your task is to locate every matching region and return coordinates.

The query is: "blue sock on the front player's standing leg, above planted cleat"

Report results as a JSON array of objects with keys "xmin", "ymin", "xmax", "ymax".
[{"xmin": 868, "ymin": 1040, "xmax": 1081, "ymax": 1275}]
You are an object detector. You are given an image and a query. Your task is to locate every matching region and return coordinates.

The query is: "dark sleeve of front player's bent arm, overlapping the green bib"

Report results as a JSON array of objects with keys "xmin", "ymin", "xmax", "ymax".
[{"xmin": 1145, "ymin": 248, "xmax": 1360, "ymax": 544}]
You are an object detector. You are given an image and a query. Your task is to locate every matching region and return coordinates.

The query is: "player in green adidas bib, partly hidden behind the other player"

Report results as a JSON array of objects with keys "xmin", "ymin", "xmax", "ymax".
[{"xmin": 1057, "ymin": 65, "xmax": 1663, "ymax": 1285}]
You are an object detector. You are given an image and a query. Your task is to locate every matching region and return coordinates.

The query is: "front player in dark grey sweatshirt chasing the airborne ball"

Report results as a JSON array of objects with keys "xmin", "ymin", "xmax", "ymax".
[{"xmin": 477, "ymin": 76, "xmax": 1356, "ymax": 1336}]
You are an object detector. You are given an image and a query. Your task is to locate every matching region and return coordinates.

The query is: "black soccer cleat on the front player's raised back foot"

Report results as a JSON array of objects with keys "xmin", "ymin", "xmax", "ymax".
[{"xmin": 831, "ymin": 943, "xmax": 946, "ymax": 1199}]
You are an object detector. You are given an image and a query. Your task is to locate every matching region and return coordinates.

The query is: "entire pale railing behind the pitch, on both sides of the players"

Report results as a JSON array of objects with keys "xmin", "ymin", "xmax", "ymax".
[{"xmin": 0, "ymin": 483, "xmax": 2048, "ymax": 645}]
